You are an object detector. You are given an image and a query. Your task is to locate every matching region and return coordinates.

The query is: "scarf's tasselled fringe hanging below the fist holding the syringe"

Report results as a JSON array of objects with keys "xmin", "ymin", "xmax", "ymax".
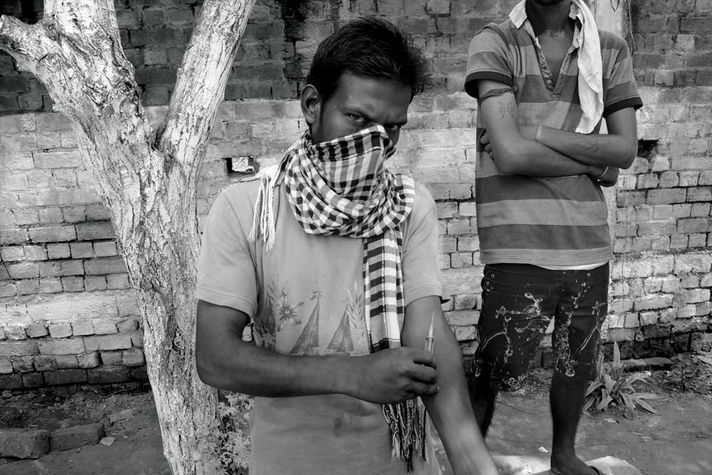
[{"xmin": 383, "ymin": 399, "xmax": 428, "ymax": 473}]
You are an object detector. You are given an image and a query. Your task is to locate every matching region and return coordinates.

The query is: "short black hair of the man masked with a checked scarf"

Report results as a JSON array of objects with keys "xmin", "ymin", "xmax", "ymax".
[{"xmin": 307, "ymin": 17, "xmax": 429, "ymax": 101}]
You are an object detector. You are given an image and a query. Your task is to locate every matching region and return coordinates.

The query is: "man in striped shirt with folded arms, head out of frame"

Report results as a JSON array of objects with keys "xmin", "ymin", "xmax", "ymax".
[{"xmin": 465, "ymin": 0, "xmax": 642, "ymax": 475}]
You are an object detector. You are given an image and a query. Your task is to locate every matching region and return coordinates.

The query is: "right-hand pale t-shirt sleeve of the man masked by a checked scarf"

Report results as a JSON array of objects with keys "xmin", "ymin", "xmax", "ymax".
[{"xmin": 401, "ymin": 184, "xmax": 443, "ymax": 305}]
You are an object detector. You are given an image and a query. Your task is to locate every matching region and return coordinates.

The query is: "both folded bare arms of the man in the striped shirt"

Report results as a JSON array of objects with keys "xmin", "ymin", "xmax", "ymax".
[{"xmin": 477, "ymin": 80, "xmax": 637, "ymax": 184}]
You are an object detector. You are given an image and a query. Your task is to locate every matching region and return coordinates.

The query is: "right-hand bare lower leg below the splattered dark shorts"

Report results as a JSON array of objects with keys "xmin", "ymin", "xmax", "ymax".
[{"xmin": 549, "ymin": 371, "xmax": 597, "ymax": 475}]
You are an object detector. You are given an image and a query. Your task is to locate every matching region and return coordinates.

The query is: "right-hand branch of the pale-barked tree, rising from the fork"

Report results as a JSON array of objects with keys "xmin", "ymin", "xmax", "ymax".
[{"xmin": 157, "ymin": 0, "xmax": 255, "ymax": 171}]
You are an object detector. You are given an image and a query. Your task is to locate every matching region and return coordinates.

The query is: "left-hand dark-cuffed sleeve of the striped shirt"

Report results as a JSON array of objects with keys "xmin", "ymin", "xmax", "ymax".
[{"xmin": 465, "ymin": 25, "xmax": 514, "ymax": 98}]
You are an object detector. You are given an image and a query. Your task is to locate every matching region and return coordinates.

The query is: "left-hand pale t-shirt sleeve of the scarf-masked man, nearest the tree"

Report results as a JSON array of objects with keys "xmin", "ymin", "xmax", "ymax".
[{"xmin": 195, "ymin": 185, "xmax": 257, "ymax": 318}]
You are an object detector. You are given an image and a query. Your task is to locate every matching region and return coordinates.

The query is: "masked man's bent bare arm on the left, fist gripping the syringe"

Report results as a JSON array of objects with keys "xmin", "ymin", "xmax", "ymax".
[{"xmin": 195, "ymin": 301, "xmax": 437, "ymax": 403}]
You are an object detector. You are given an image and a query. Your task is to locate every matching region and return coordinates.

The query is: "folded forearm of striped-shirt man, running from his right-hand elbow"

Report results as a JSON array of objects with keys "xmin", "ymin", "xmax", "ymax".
[{"xmin": 536, "ymin": 126, "xmax": 637, "ymax": 168}]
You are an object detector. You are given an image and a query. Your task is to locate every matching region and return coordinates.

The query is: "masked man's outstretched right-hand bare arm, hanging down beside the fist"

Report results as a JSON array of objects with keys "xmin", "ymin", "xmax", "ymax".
[{"xmin": 401, "ymin": 298, "xmax": 497, "ymax": 474}]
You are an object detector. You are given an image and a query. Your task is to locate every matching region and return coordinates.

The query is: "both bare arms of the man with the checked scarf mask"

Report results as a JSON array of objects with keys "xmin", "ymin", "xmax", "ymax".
[{"xmin": 196, "ymin": 297, "xmax": 497, "ymax": 474}]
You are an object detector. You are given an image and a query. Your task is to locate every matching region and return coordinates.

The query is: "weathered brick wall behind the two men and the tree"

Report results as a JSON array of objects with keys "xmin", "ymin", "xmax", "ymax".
[{"xmin": 0, "ymin": 0, "xmax": 712, "ymax": 388}]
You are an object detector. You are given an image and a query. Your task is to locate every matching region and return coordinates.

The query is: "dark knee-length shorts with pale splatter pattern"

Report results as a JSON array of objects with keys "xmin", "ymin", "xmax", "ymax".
[{"xmin": 474, "ymin": 264, "xmax": 608, "ymax": 391}]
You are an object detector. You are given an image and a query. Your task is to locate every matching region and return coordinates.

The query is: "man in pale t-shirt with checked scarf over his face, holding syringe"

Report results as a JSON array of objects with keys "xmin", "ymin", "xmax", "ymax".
[{"xmin": 196, "ymin": 19, "xmax": 496, "ymax": 475}]
